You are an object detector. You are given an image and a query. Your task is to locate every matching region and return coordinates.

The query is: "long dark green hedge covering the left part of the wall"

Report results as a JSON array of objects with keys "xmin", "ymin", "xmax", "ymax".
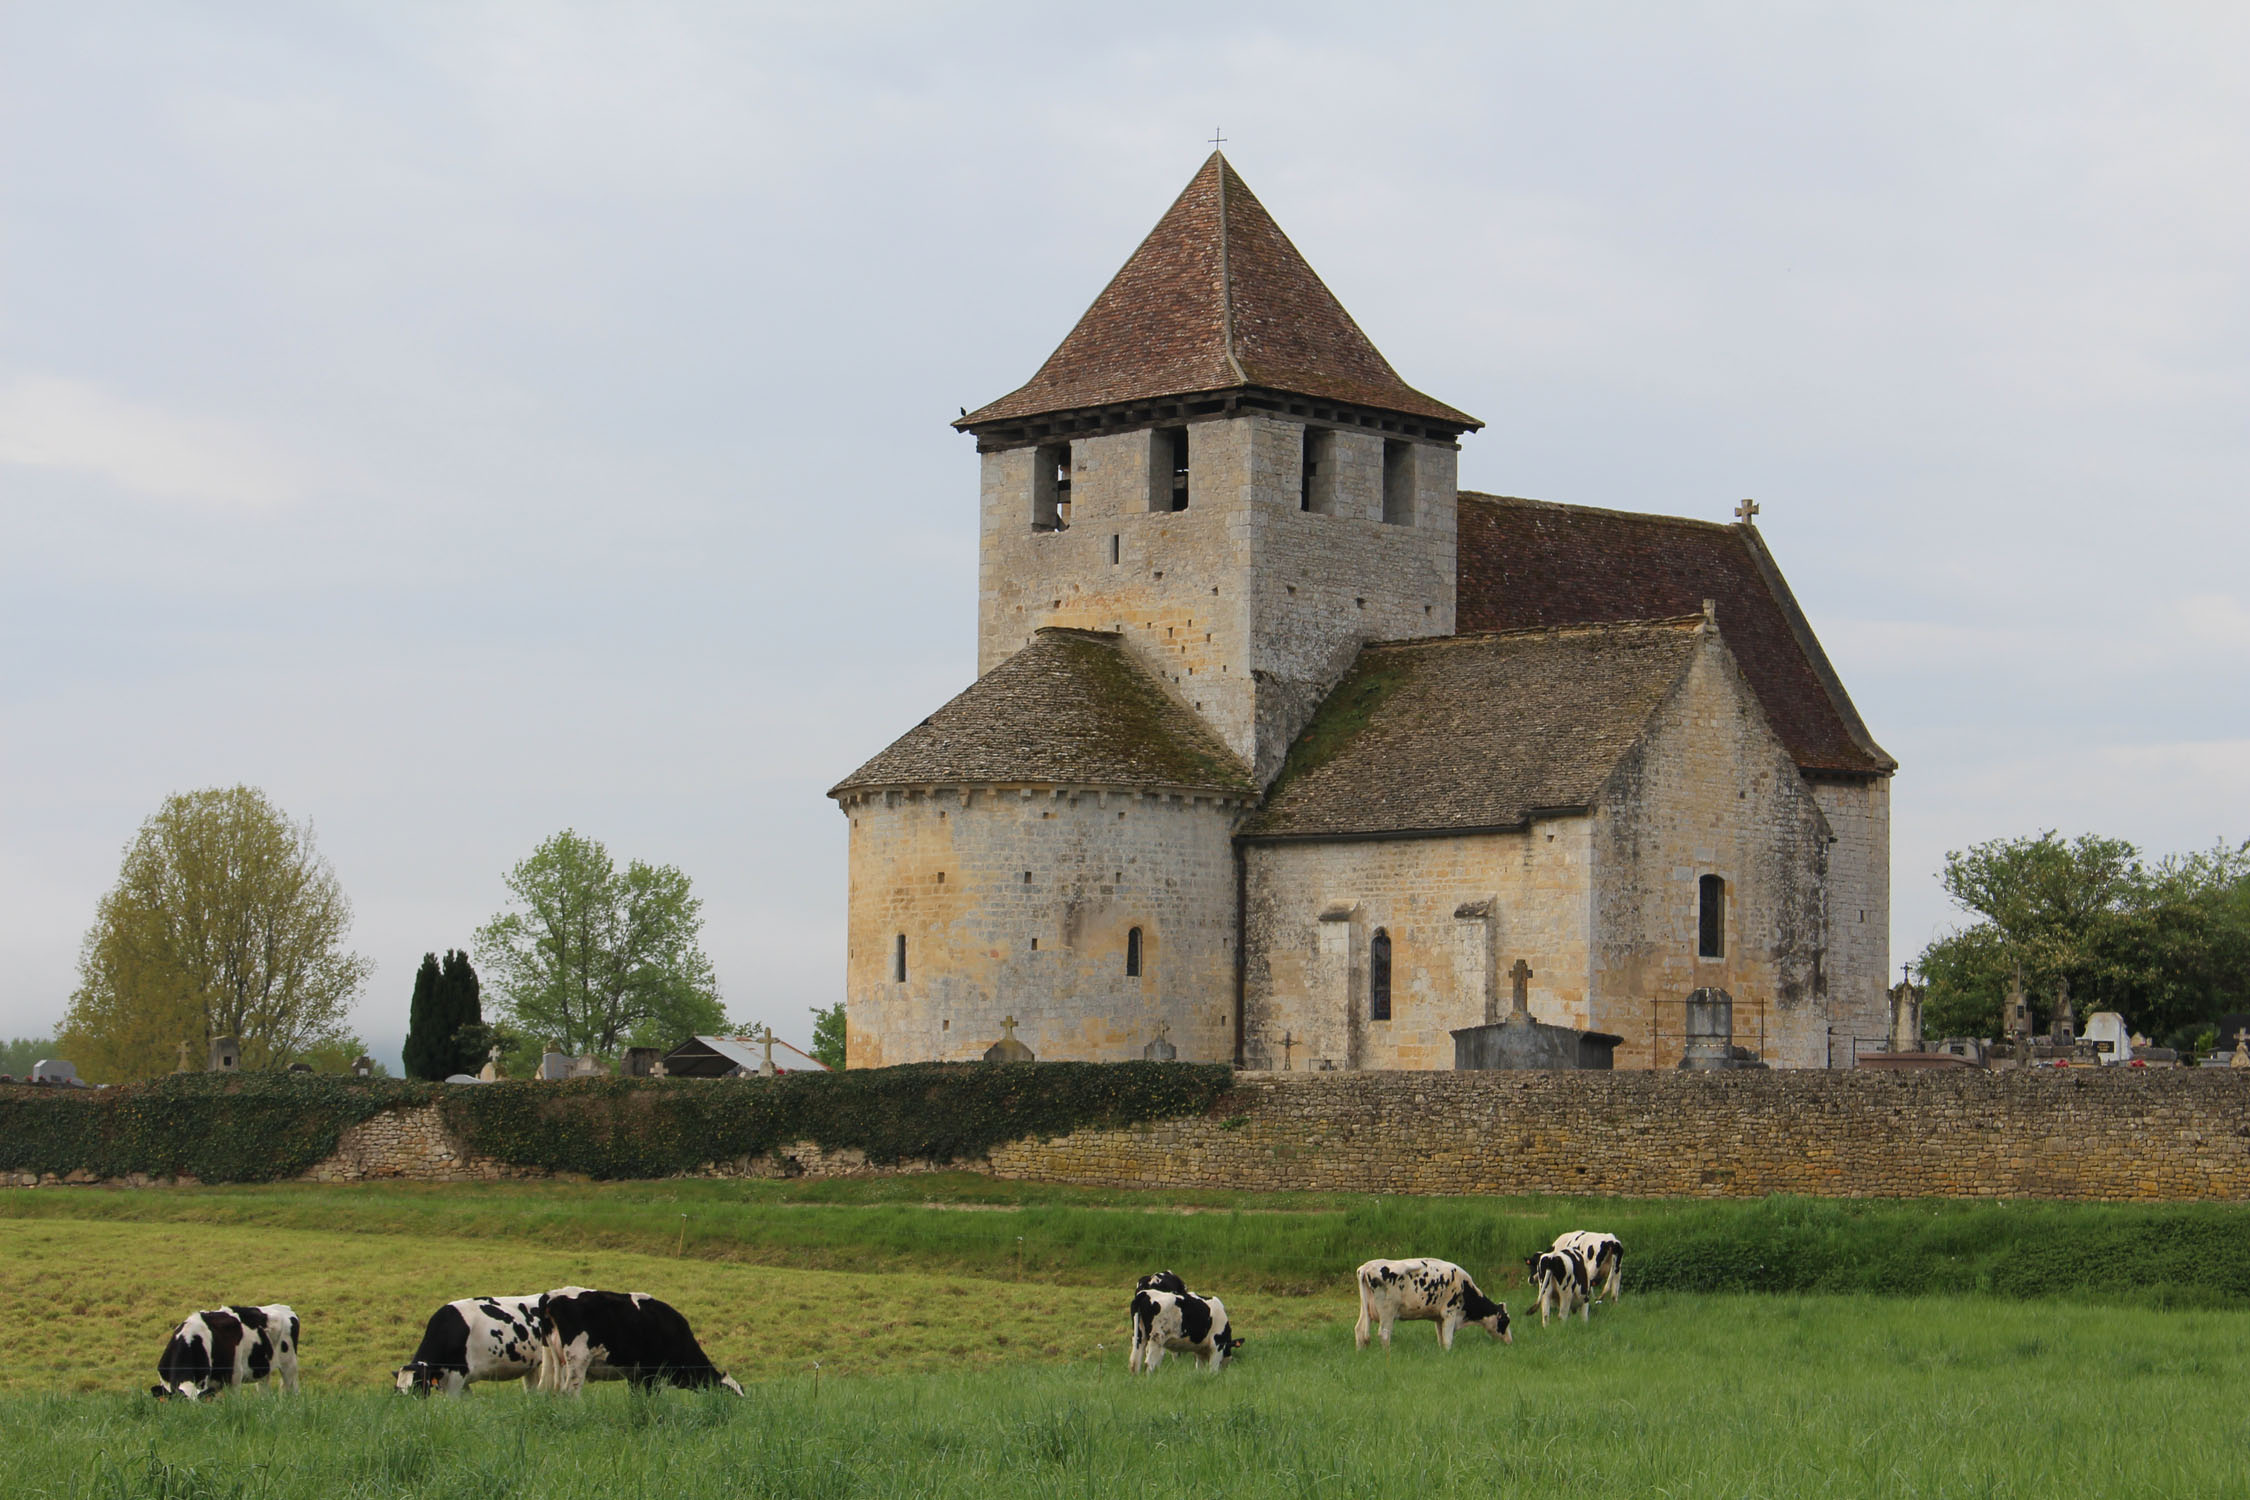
[{"xmin": 0, "ymin": 1061, "xmax": 1233, "ymax": 1183}]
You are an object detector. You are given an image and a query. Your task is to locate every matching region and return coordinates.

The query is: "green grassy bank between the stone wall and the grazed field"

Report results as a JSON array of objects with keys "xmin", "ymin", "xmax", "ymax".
[{"xmin": 13, "ymin": 1174, "xmax": 2250, "ymax": 1307}]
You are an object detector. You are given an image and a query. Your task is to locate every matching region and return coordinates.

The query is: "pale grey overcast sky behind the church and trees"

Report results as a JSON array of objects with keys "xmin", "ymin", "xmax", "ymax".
[{"xmin": 0, "ymin": 0, "xmax": 2250, "ymax": 1066}]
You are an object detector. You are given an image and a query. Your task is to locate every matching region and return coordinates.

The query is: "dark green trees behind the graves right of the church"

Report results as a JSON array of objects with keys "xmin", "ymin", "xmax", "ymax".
[{"xmin": 1919, "ymin": 830, "xmax": 2250, "ymax": 1037}]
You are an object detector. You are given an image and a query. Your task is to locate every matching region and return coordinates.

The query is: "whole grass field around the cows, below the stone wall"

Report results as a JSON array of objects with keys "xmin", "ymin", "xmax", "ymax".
[{"xmin": 0, "ymin": 1178, "xmax": 2250, "ymax": 1500}]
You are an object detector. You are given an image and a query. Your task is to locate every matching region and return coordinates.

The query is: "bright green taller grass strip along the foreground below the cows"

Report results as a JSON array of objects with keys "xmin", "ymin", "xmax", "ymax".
[{"xmin": 0, "ymin": 1293, "xmax": 2250, "ymax": 1500}]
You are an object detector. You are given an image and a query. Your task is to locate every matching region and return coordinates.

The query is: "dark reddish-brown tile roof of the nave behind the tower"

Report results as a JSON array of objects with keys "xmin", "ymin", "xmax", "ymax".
[{"xmin": 1456, "ymin": 490, "xmax": 1899, "ymax": 776}]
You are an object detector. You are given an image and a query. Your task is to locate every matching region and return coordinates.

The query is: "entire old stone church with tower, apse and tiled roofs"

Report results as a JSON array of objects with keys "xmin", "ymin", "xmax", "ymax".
[{"xmin": 830, "ymin": 155, "xmax": 1897, "ymax": 1070}]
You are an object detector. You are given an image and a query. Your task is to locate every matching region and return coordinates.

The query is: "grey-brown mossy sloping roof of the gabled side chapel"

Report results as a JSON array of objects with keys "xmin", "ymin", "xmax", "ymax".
[{"xmin": 1244, "ymin": 618, "xmax": 1699, "ymax": 837}]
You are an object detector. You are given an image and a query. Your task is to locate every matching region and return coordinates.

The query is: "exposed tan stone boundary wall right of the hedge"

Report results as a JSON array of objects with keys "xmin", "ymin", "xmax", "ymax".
[{"xmin": 990, "ymin": 1068, "xmax": 2250, "ymax": 1201}]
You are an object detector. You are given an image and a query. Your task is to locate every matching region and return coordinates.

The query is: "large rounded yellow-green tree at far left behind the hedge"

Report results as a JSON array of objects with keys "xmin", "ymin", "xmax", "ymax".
[{"xmin": 56, "ymin": 787, "xmax": 369, "ymax": 1082}]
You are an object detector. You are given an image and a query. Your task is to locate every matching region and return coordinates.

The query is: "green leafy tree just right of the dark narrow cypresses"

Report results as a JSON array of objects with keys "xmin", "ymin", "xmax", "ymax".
[{"xmin": 477, "ymin": 828, "xmax": 727, "ymax": 1057}]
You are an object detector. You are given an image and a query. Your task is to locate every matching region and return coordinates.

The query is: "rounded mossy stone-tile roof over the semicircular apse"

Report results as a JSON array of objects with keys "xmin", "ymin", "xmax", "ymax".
[{"xmin": 828, "ymin": 627, "xmax": 1256, "ymax": 796}]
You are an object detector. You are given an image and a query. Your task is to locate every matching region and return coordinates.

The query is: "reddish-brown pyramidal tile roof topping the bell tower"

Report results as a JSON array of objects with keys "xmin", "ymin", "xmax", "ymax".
[{"xmin": 954, "ymin": 151, "xmax": 1483, "ymax": 430}]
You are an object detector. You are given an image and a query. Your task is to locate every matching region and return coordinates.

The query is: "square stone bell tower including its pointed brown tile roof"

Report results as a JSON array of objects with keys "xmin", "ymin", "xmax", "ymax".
[{"xmin": 954, "ymin": 153, "xmax": 1483, "ymax": 785}]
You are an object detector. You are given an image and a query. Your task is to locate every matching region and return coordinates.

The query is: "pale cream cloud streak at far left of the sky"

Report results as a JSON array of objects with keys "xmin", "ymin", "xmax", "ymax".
[{"xmin": 0, "ymin": 376, "xmax": 299, "ymax": 508}]
